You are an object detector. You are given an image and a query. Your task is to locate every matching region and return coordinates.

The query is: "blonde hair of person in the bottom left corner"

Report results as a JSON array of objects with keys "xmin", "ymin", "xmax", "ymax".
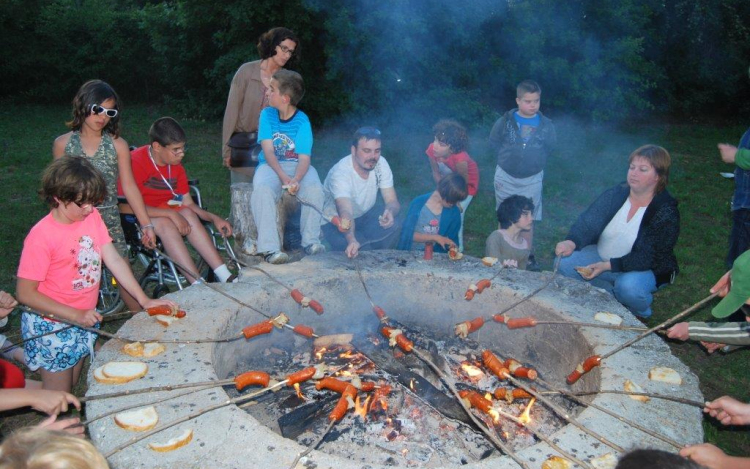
[{"xmin": 0, "ymin": 428, "xmax": 109, "ymax": 469}]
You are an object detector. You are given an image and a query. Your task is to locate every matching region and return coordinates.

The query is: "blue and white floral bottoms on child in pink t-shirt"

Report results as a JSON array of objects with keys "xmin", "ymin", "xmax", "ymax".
[{"xmin": 21, "ymin": 313, "xmax": 99, "ymax": 371}]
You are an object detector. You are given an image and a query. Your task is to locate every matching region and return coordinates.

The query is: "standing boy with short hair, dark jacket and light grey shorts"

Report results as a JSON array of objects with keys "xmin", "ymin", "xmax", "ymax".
[{"xmin": 490, "ymin": 80, "xmax": 557, "ymax": 264}]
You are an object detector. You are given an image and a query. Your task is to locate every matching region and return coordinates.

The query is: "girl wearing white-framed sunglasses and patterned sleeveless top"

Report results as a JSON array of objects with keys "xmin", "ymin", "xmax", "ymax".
[{"xmin": 52, "ymin": 80, "xmax": 156, "ymax": 311}]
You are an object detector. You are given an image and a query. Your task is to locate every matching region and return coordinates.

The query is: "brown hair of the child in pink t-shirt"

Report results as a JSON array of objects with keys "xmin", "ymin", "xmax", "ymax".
[{"xmin": 39, "ymin": 156, "xmax": 107, "ymax": 208}]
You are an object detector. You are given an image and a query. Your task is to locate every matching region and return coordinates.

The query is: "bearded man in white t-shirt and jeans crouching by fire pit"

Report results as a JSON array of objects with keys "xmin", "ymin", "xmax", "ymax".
[{"xmin": 321, "ymin": 127, "xmax": 401, "ymax": 258}]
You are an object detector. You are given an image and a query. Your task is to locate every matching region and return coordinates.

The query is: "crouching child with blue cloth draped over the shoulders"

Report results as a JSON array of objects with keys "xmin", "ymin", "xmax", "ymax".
[{"xmin": 398, "ymin": 173, "xmax": 466, "ymax": 252}]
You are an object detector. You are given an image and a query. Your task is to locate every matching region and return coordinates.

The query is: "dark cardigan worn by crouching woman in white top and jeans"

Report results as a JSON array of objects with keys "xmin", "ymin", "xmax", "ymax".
[{"xmin": 567, "ymin": 183, "xmax": 680, "ymax": 285}]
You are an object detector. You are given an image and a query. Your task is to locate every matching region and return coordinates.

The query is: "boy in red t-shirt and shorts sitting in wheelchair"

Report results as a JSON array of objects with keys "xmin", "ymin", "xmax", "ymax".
[{"xmin": 123, "ymin": 117, "xmax": 236, "ymax": 283}]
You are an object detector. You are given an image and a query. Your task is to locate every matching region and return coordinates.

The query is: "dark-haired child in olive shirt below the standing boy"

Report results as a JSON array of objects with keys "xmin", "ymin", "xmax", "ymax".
[{"xmin": 484, "ymin": 195, "xmax": 534, "ymax": 270}]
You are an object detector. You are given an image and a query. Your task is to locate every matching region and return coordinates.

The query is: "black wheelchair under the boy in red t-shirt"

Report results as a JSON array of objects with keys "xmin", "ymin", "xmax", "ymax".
[{"xmin": 96, "ymin": 179, "xmax": 239, "ymax": 314}]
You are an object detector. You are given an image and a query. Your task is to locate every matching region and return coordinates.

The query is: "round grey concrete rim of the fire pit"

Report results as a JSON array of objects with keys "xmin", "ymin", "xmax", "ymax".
[{"xmin": 86, "ymin": 251, "xmax": 703, "ymax": 469}]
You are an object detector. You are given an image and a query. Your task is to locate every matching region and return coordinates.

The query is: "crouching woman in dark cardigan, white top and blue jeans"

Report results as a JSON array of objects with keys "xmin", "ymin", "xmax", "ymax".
[{"xmin": 555, "ymin": 145, "xmax": 680, "ymax": 318}]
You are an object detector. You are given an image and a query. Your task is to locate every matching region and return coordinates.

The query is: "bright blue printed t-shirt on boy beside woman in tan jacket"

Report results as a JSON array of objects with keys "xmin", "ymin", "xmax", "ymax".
[{"xmin": 258, "ymin": 107, "xmax": 312, "ymax": 164}]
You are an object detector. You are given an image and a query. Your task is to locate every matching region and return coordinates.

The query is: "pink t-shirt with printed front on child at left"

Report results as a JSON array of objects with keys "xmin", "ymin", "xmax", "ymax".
[{"xmin": 18, "ymin": 209, "xmax": 112, "ymax": 310}]
